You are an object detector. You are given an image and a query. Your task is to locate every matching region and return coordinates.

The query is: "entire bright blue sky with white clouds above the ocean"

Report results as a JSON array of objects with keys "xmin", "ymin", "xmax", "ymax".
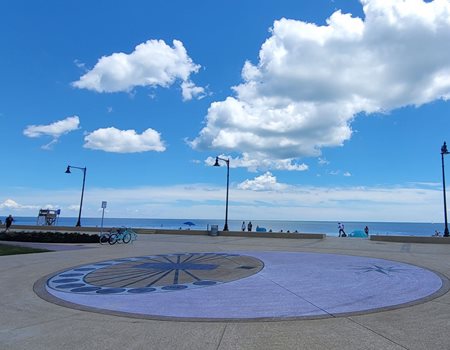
[{"xmin": 0, "ymin": 0, "xmax": 450, "ymax": 222}]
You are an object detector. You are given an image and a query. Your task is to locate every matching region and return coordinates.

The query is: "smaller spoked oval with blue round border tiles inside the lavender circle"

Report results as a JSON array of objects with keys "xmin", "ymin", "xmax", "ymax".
[{"xmin": 47, "ymin": 253, "xmax": 263, "ymax": 294}]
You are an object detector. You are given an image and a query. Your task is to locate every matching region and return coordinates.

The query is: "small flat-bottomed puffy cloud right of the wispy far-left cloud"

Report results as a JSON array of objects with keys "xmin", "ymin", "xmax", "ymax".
[{"xmin": 83, "ymin": 127, "xmax": 166, "ymax": 153}]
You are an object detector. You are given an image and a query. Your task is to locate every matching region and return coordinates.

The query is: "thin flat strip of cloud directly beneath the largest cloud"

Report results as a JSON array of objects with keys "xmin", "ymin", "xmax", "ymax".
[{"xmin": 205, "ymin": 152, "xmax": 308, "ymax": 172}]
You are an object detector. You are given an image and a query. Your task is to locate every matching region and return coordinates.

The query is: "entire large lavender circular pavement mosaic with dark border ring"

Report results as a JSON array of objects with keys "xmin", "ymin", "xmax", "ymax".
[{"xmin": 34, "ymin": 251, "xmax": 449, "ymax": 321}]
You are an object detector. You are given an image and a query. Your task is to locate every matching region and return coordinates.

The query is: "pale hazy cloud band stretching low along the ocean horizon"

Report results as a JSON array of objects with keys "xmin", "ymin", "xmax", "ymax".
[{"xmin": 0, "ymin": 182, "xmax": 442, "ymax": 223}]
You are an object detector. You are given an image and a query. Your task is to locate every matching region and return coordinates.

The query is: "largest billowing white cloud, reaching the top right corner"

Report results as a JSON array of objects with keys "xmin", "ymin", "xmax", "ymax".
[{"xmin": 190, "ymin": 0, "xmax": 450, "ymax": 167}]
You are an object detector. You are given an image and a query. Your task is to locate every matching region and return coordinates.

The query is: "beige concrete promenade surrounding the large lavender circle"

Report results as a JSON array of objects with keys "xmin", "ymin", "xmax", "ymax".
[{"xmin": 0, "ymin": 234, "xmax": 450, "ymax": 350}]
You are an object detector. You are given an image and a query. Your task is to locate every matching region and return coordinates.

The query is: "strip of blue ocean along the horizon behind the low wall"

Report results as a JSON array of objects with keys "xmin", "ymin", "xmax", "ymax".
[{"xmin": 7, "ymin": 217, "xmax": 444, "ymax": 236}]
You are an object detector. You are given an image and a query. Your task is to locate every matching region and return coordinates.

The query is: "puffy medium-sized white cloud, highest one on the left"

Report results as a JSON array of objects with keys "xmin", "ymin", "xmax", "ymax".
[{"xmin": 72, "ymin": 40, "xmax": 204, "ymax": 100}]
